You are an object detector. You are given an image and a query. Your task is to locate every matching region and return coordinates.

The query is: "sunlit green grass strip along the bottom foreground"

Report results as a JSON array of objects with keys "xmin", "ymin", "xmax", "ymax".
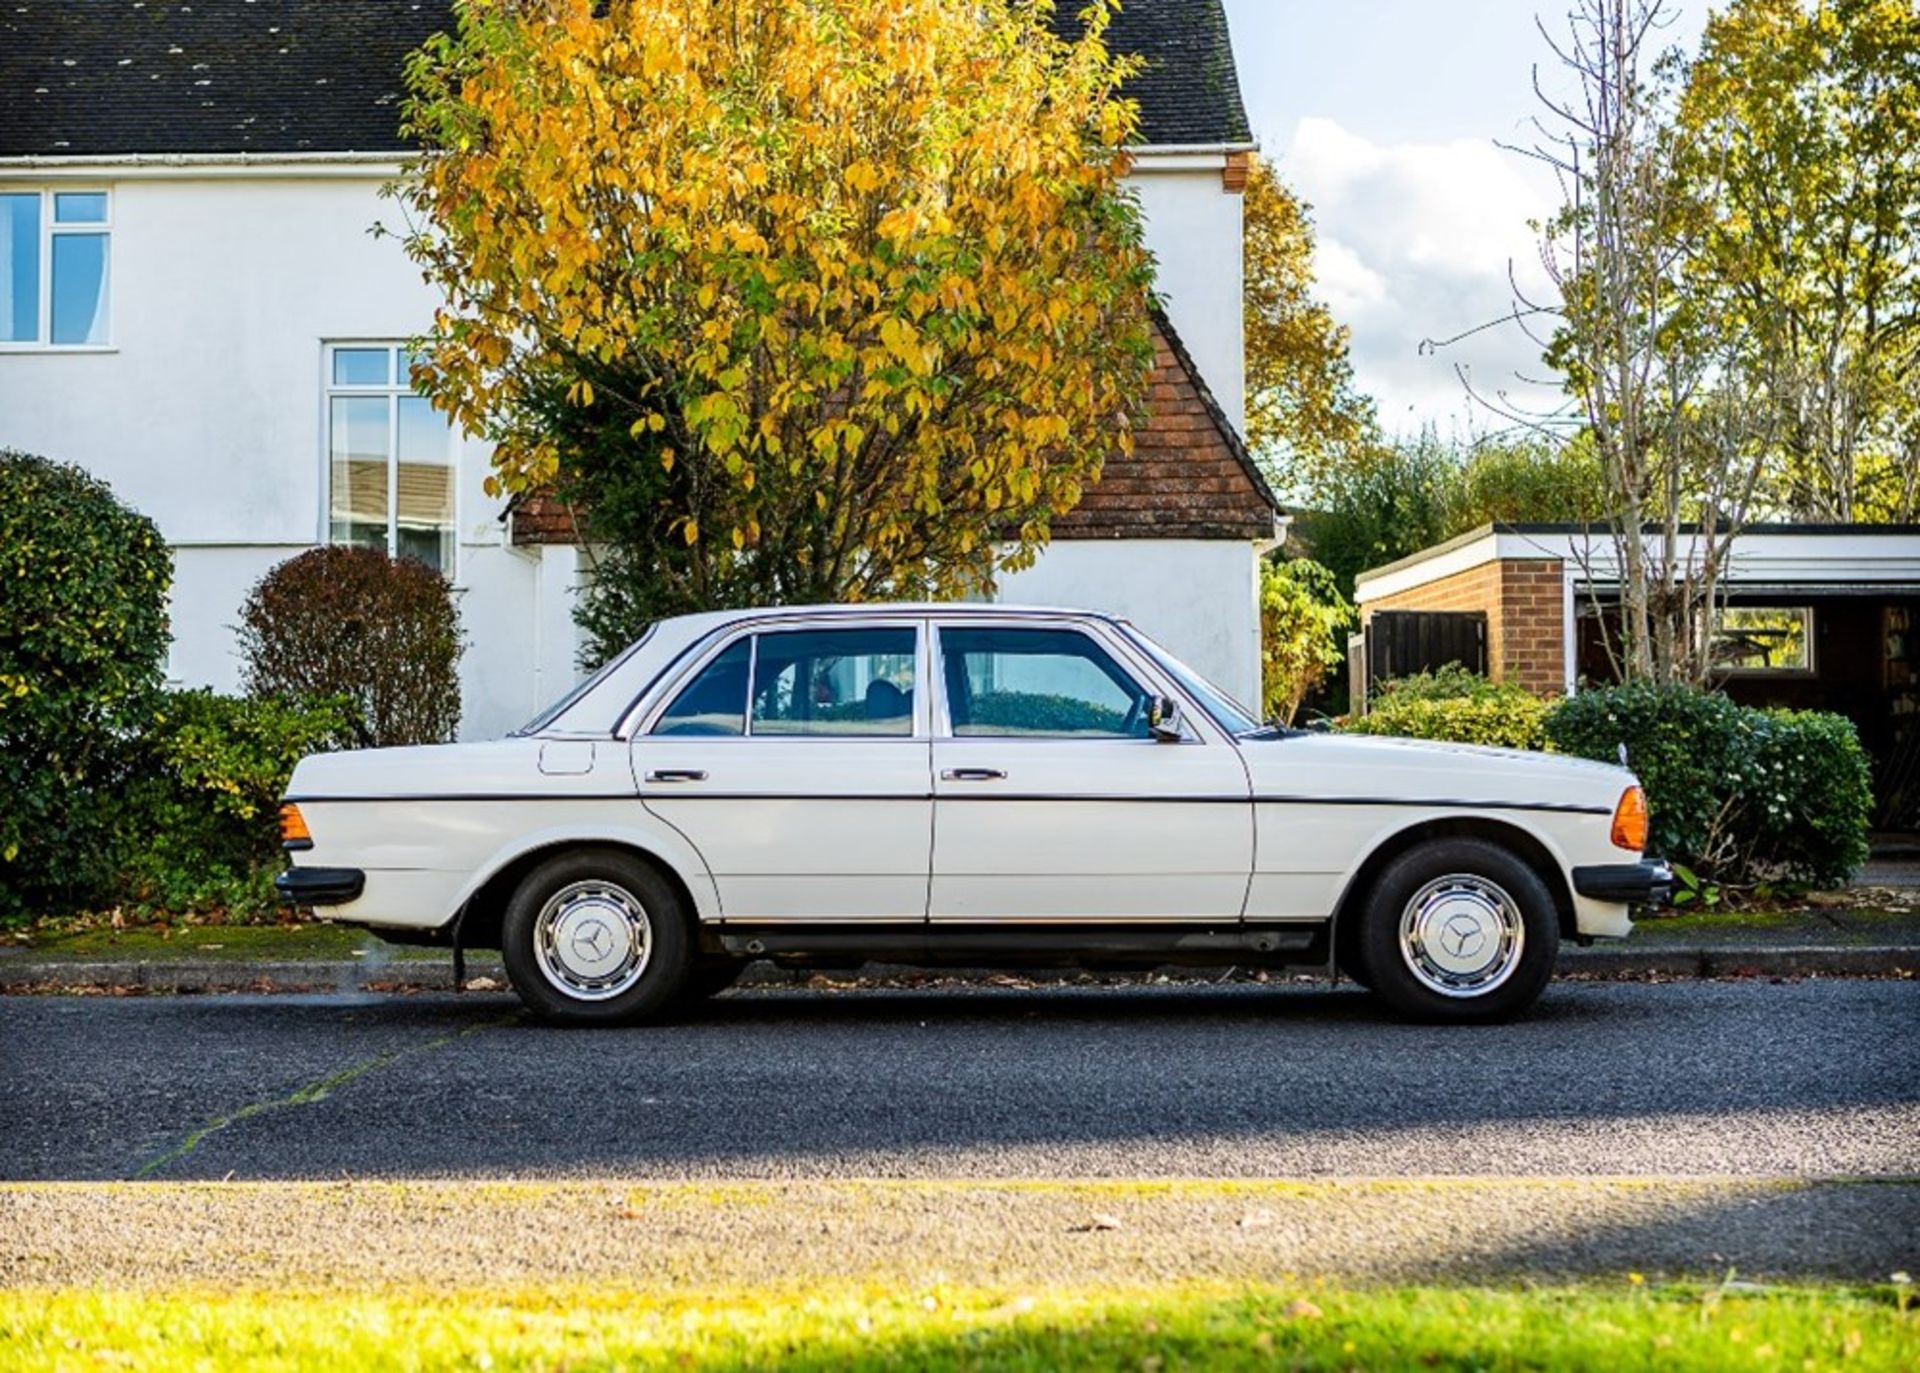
[{"xmin": 0, "ymin": 1275, "xmax": 1920, "ymax": 1371}]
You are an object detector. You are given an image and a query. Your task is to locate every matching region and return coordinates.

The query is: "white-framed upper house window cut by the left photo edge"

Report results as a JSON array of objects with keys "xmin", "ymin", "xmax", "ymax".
[{"xmin": 0, "ymin": 190, "xmax": 111, "ymax": 348}]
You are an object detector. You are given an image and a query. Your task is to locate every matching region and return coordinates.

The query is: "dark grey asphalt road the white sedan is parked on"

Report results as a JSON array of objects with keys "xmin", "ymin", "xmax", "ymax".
[{"xmin": 0, "ymin": 981, "xmax": 1920, "ymax": 1179}]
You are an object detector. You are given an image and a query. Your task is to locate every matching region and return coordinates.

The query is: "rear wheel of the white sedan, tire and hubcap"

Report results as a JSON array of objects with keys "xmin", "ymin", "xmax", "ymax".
[{"xmin": 501, "ymin": 849, "xmax": 693, "ymax": 1025}]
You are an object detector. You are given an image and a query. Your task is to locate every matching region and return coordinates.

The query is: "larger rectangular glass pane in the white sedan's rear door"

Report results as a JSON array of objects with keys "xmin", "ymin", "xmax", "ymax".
[{"xmin": 753, "ymin": 628, "xmax": 914, "ymax": 735}]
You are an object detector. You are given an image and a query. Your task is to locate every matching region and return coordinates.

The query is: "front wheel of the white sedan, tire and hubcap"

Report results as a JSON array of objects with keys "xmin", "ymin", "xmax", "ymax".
[{"xmin": 1356, "ymin": 839, "xmax": 1559, "ymax": 1024}]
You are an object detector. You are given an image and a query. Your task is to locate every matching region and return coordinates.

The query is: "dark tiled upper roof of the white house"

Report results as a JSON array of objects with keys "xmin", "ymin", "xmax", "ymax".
[{"xmin": 0, "ymin": 0, "xmax": 1248, "ymax": 157}]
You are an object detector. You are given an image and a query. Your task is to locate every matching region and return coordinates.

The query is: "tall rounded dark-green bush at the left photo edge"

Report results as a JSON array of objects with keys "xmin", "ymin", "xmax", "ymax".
[{"xmin": 0, "ymin": 449, "xmax": 173, "ymax": 918}]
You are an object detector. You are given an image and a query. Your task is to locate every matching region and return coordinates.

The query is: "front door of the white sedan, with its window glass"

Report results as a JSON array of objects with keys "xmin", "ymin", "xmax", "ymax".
[{"xmin": 929, "ymin": 616, "xmax": 1254, "ymax": 922}]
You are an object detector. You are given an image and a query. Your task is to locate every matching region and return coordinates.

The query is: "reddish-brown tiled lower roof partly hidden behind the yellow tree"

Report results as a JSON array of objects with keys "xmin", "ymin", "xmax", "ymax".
[{"xmin": 507, "ymin": 315, "xmax": 1281, "ymax": 547}]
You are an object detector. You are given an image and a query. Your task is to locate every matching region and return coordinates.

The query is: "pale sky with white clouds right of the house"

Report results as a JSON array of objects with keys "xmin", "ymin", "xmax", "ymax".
[{"xmin": 1225, "ymin": 0, "xmax": 1707, "ymax": 438}]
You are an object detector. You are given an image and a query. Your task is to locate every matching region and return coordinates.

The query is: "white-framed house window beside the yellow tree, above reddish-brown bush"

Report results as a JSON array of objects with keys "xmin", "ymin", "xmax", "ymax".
[{"xmin": 326, "ymin": 344, "xmax": 455, "ymax": 578}]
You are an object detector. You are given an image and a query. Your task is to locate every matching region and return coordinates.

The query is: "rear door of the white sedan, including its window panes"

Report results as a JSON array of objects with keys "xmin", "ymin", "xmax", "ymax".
[{"xmin": 634, "ymin": 618, "xmax": 933, "ymax": 924}]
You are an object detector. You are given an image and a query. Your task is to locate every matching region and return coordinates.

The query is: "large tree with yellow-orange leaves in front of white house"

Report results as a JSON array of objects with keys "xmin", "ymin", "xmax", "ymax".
[{"xmin": 396, "ymin": 0, "xmax": 1152, "ymax": 622}]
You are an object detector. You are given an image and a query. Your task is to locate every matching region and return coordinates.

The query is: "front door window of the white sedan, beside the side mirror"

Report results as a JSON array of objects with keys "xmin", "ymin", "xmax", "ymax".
[{"xmin": 941, "ymin": 628, "xmax": 1150, "ymax": 739}]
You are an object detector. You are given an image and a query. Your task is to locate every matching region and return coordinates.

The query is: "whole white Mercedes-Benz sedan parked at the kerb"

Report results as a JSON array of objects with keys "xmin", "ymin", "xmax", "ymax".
[{"xmin": 278, "ymin": 605, "xmax": 1672, "ymax": 1022}]
